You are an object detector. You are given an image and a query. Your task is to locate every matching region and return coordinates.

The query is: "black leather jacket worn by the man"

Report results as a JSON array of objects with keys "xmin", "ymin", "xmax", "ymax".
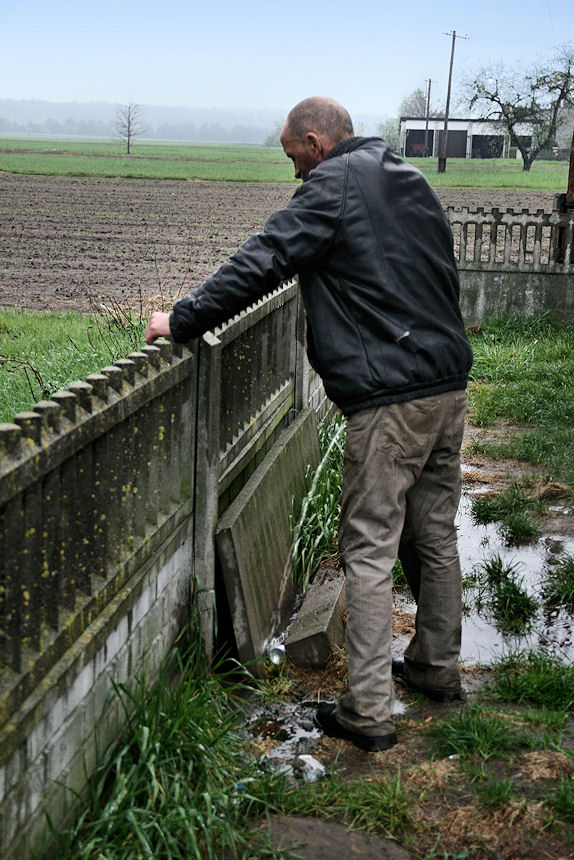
[{"xmin": 170, "ymin": 138, "xmax": 472, "ymax": 414}]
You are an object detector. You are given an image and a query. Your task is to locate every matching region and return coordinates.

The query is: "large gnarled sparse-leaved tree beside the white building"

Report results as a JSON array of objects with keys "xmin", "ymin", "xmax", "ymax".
[{"xmin": 466, "ymin": 47, "xmax": 574, "ymax": 170}]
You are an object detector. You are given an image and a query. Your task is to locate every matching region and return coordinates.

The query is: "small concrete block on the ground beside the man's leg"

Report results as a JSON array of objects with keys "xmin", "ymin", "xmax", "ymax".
[{"xmin": 285, "ymin": 573, "xmax": 347, "ymax": 669}]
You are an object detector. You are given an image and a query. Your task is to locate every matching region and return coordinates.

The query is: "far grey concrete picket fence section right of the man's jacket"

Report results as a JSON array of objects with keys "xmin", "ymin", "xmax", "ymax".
[{"xmin": 447, "ymin": 207, "xmax": 574, "ymax": 325}]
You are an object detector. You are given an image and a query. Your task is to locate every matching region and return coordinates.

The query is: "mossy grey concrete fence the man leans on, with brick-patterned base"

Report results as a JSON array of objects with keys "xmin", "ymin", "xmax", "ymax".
[{"xmin": 0, "ymin": 281, "xmax": 327, "ymax": 858}]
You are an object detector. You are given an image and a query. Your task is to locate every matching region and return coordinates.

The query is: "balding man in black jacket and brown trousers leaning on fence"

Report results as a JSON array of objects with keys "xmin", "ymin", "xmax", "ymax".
[{"xmin": 146, "ymin": 97, "xmax": 472, "ymax": 750}]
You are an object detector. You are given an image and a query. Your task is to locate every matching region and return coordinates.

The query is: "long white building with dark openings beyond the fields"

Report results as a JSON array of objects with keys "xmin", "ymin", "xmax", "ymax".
[{"xmin": 399, "ymin": 116, "xmax": 532, "ymax": 158}]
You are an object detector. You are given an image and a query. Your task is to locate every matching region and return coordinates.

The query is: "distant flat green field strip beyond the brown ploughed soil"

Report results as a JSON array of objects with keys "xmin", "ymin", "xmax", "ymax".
[{"xmin": 0, "ymin": 138, "xmax": 568, "ymax": 191}]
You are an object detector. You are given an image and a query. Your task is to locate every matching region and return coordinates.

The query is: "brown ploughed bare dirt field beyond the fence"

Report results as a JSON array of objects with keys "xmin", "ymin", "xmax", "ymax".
[{"xmin": 0, "ymin": 174, "xmax": 554, "ymax": 310}]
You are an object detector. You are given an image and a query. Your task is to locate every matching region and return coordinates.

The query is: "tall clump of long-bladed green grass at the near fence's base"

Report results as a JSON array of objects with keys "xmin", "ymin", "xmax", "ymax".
[{"xmin": 48, "ymin": 643, "xmax": 283, "ymax": 860}]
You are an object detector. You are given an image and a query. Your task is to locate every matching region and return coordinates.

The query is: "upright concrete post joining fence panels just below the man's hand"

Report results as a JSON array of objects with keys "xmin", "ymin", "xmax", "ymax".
[{"xmin": 193, "ymin": 332, "xmax": 222, "ymax": 660}]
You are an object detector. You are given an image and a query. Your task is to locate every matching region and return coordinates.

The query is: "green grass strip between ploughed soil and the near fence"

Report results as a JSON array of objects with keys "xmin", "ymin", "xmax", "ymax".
[{"xmin": 0, "ymin": 308, "xmax": 145, "ymax": 422}]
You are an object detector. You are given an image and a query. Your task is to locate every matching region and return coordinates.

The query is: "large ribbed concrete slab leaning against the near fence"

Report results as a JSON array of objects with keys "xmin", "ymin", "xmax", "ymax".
[{"xmin": 215, "ymin": 410, "xmax": 320, "ymax": 675}]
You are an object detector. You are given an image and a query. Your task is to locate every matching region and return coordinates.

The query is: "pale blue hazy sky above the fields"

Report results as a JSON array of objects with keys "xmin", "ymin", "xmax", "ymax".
[{"xmin": 0, "ymin": 0, "xmax": 574, "ymax": 119}]
